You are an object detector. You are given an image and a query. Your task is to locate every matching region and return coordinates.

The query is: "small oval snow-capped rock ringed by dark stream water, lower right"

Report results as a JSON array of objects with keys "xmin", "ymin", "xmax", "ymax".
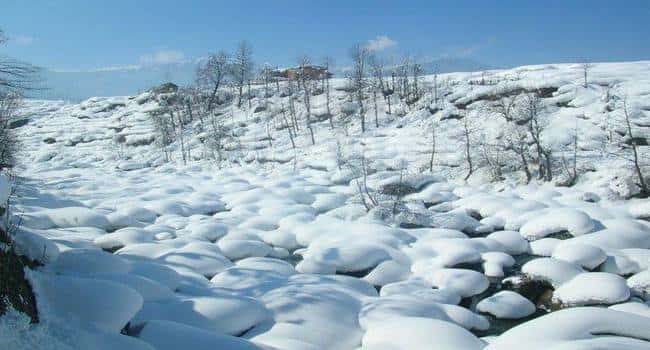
[{"xmin": 476, "ymin": 290, "xmax": 535, "ymax": 319}]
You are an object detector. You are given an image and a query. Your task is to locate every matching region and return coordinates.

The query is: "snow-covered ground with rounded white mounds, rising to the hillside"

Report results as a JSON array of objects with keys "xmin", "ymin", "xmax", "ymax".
[{"xmin": 0, "ymin": 62, "xmax": 650, "ymax": 350}]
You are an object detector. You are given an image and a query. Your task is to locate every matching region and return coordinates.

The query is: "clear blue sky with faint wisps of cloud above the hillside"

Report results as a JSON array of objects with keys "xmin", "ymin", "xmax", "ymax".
[{"xmin": 0, "ymin": 0, "xmax": 650, "ymax": 70}]
